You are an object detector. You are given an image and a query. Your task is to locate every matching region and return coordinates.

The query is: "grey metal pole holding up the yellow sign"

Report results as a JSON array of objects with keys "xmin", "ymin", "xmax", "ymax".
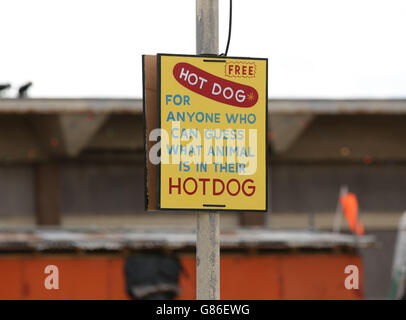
[{"xmin": 196, "ymin": 0, "xmax": 220, "ymax": 300}]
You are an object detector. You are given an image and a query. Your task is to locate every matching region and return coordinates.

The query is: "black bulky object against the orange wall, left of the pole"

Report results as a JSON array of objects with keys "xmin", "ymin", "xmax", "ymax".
[{"xmin": 125, "ymin": 254, "xmax": 181, "ymax": 300}]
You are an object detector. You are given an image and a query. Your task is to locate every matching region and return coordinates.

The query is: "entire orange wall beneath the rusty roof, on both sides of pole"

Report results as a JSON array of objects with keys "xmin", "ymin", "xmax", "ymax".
[{"xmin": 0, "ymin": 254, "xmax": 362, "ymax": 299}]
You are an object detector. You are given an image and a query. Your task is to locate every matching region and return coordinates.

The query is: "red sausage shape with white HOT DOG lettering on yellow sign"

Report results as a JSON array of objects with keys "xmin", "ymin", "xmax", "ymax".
[{"xmin": 173, "ymin": 62, "xmax": 258, "ymax": 108}]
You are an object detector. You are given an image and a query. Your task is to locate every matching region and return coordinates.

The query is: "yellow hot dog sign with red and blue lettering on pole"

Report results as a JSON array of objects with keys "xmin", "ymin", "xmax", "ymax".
[{"xmin": 158, "ymin": 54, "xmax": 268, "ymax": 211}]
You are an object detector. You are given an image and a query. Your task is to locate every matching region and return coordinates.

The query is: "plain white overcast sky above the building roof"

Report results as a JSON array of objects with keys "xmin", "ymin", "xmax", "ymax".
[{"xmin": 0, "ymin": 0, "xmax": 406, "ymax": 98}]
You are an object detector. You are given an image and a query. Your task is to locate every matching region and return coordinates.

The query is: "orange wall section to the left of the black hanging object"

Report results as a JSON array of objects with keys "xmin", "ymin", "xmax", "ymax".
[{"xmin": 0, "ymin": 256, "xmax": 127, "ymax": 299}]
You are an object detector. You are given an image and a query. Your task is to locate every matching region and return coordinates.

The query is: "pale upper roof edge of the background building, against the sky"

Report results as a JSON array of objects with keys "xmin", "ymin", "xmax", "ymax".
[{"xmin": 0, "ymin": 98, "xmax": 406, "ymax": 114}]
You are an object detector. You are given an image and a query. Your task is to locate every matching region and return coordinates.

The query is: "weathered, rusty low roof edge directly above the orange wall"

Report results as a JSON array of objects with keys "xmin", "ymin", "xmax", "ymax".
[{"xmin": 0, "ymin": 228, "xmax": 375, "ymax": 252}]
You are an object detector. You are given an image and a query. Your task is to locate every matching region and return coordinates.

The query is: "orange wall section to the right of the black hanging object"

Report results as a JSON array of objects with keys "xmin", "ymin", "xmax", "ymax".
[{"xmin": 179, "ymin": 254, "xmax": 363, "ymax": 299}]
